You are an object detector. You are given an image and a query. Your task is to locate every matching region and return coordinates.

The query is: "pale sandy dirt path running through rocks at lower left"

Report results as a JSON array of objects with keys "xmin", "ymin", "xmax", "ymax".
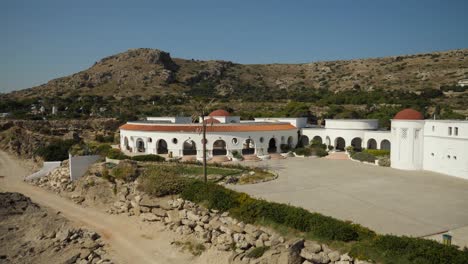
[{"xmin": 0, "ymin": 151, "xmax": 193, "ymax": 264}]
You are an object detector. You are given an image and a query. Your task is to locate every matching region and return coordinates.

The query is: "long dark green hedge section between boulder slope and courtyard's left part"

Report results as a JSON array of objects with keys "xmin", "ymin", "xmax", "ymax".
[{"xmin": 181, "ymin": 181, "xmax": 375, "ymax": 242}]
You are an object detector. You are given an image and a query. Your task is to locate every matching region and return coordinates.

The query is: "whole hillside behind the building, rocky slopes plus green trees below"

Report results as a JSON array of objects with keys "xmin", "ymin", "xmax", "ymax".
[{"xmin": 0, "ymin": 49, "xmax": 468, "ymax": 119}]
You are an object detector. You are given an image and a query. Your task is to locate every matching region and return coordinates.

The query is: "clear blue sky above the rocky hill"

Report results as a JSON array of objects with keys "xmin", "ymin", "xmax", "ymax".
[{"xmin": 0, "ymin": 0, "xmax": 468, "ymax": 92}]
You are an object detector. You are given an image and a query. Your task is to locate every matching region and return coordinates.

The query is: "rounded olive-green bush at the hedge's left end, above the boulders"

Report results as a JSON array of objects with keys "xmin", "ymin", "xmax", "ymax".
[{"xmin": 138, "ymin": 166, "xmax": 191, "ymax": 197}]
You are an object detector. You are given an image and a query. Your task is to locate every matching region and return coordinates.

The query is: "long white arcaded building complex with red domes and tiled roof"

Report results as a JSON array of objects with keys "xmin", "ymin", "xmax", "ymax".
[{"xmin": 120, "ymin": 109, "xmax": 468, "ymax": 179}]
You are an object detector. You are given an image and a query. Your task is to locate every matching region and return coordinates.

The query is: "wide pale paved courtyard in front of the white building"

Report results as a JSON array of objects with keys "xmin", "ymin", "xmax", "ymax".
[{"xmin": 232, "ymin": 158, "xmax": 468, "ymax": 241}]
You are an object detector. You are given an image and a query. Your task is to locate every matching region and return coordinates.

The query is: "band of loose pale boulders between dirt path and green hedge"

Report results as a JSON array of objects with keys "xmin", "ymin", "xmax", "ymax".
[{"xmin": 29, "ymin": 161, "xmax": 368, "ymax": 264}]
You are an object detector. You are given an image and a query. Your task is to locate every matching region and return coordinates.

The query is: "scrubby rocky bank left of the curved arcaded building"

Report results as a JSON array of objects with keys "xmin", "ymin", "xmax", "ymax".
[{"xmin": 0, "ymin": 118, "xmax": 119, "ymax": 158}]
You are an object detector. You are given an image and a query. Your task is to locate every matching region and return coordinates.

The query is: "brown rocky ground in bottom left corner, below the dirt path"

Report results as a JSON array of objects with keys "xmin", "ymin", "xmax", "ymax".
[{"xmin": 0, "ymin": 192, "xmax": 114, "ymax": 264}]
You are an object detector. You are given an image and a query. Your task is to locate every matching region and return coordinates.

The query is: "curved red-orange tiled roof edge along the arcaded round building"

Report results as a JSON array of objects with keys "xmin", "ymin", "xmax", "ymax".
[{"xmin": 120, "ymin": 123, "xmax": 296, "ymax": 132}]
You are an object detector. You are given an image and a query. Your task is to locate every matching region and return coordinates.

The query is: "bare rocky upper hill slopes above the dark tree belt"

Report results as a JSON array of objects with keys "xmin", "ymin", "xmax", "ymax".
[{"xmin": 7, "ymin": 49, "xmax": 468, "ymax": 99}]
